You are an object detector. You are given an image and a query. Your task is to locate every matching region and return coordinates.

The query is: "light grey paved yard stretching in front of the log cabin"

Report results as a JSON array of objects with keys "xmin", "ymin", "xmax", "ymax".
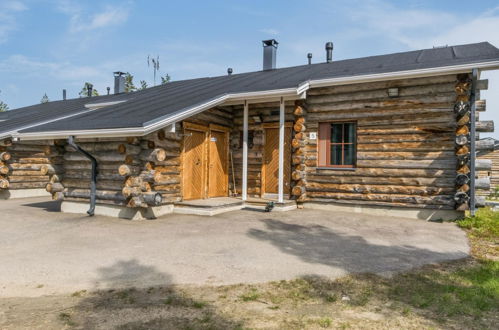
[{"xmin": 0, "ymin": 198, "xmax": 469, "ymax": 297}]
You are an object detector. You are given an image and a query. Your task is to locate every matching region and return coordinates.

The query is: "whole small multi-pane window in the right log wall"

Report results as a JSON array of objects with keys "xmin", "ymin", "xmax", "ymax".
[{"xmin": 318, "ymin": 123, "xmax": 357, "ymax": 167}]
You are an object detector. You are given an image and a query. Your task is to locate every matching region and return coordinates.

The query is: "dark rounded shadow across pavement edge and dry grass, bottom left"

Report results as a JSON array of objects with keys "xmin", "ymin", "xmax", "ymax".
[{"xmin": 67, "ymin": 260, "xmax": 244, "ymax": 329}]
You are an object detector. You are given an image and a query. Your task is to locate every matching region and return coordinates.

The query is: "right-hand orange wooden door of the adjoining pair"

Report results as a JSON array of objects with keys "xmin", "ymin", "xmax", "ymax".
[{"xmin": 208, "ymin": 125, "xmax": 229, "ymax": 197}]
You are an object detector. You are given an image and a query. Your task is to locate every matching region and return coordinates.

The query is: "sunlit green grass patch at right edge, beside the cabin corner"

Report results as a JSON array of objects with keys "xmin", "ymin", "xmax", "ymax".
[{"xmin": 457, "ymin": 208, "xmax": 499, "ymax": 238}]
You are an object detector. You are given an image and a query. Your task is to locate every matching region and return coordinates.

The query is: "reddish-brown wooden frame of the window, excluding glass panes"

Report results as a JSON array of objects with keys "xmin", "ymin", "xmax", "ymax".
[{"xmin": 317, "ymin": 120, "xmax": 358, "ymax": 169}]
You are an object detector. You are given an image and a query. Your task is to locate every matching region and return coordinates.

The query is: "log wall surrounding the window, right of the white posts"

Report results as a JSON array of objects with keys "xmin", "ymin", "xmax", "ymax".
[{"xmin": 293, "ymin": 75, "xmax": 457, "ymax": 209}]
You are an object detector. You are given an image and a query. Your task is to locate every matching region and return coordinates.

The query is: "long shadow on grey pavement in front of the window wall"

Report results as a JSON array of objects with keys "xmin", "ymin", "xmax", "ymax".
[{"xmin": 248, "ymin": 219, "xmax": 467, "ymax": 273}]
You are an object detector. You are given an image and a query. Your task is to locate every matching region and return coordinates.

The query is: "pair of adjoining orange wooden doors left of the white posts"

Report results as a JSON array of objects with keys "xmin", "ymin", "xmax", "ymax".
[{"xmin": 182, "ymin": 123, "xmax": 229, "ymax": 200}]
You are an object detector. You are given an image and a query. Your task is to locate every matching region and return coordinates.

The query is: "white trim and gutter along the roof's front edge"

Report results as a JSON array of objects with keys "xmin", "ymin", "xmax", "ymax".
[{"xmin": 11, "ymin": 61, "xmax": 499, "ymax": 140}]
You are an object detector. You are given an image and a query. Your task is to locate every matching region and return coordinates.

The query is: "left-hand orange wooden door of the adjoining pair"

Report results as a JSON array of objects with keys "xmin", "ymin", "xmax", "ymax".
[{"xmin": 182, "ymin": 123, "xmax": 208, "ymax": 200}]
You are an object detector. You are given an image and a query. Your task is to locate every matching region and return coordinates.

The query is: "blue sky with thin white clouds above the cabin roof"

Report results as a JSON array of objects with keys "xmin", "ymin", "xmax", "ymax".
[{"xmin": 0, "ymin": 0, "xmax": 499, "ymax": 137}]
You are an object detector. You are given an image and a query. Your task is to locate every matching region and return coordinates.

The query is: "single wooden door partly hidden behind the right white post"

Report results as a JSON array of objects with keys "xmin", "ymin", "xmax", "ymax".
[{"xmin": 262, "ymin": 123, "xmax": 292, "ymax": 194}]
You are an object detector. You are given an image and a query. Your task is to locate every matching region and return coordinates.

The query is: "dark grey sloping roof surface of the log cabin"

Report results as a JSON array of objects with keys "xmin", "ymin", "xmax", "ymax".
[{"xmin": 0, "ymin": 42, "xmax": 499, "ymax": 134}]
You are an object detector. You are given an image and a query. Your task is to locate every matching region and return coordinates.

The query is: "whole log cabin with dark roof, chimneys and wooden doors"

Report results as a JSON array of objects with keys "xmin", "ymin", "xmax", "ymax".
[{"xmin": 0, "ymin": 40, "xmax": 499, "ymax": 220}]
